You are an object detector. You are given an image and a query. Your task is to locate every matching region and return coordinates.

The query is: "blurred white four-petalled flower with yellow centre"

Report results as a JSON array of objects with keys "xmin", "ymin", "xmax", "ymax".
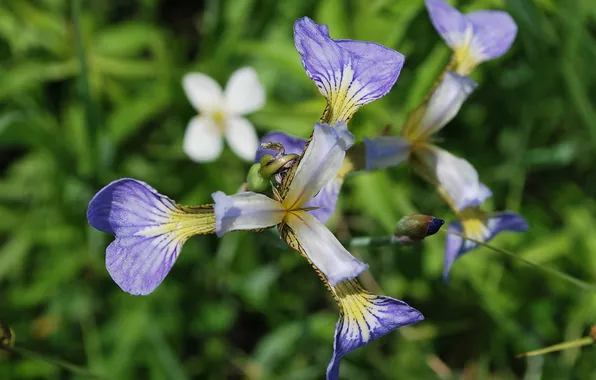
[{"xmin": 182, "ymin": 67, "xmax": 265, "ymax": 162}]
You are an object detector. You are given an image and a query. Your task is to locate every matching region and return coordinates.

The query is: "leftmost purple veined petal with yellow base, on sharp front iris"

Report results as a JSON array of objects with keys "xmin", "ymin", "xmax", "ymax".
[{"xmin": 87, "ymin": 178, "xmax": 215, "ymax": 295}]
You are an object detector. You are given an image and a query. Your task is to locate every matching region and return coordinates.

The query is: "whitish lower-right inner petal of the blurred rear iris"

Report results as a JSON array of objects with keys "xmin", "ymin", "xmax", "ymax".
[{"xmin": 416, "ymin": 146, "xmax": 492, "ymax": 210}]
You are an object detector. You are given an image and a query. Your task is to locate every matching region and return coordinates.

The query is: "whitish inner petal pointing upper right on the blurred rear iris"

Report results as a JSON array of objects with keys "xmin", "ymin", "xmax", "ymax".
[{"xmin": 412, "ymin": 71, "xmax": 477, "ymax": 138}]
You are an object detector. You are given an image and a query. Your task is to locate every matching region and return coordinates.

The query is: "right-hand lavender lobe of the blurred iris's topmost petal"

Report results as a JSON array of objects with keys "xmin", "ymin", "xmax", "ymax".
[{"xmin": 466, "ymin": 11, "xmax": 517, "ymax": 63}]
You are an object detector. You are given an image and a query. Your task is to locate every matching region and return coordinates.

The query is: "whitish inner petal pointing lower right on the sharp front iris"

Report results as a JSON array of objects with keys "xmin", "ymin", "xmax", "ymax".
[{"xmin": 280, "ymin": 211, "xmax": 368, "ymax": 286}]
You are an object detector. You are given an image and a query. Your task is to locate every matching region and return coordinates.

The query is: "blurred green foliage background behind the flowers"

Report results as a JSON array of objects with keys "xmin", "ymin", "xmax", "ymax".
[{"xmin": 0, "ymin": 0, "xmax": 596, "ymax": 380}]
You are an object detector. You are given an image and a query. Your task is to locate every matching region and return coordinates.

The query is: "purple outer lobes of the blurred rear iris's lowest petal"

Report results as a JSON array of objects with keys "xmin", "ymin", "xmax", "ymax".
[{"xmin": 443, "ymin": 211, "xmax": 529, "ymax": 280}]
